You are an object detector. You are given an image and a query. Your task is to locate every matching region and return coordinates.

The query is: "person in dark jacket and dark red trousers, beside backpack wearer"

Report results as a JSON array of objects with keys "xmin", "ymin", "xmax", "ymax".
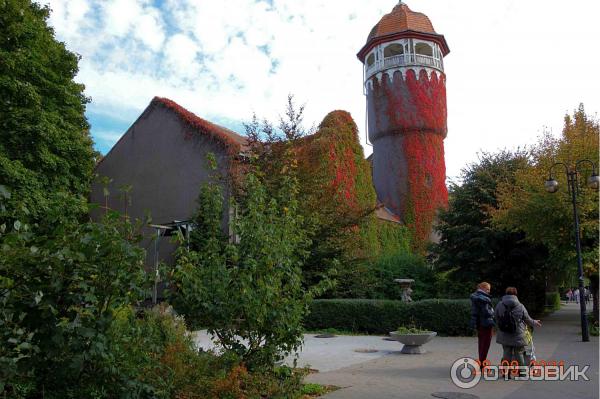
[{"xmin": 471, "ymin": 281, "xmax": 496, "ymax": 368}]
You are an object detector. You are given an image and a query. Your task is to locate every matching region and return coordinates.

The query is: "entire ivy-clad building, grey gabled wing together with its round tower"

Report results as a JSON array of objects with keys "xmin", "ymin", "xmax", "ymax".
[{"xmin": 91, "ymin": 3, "xmax": 449, "ymax": 276}]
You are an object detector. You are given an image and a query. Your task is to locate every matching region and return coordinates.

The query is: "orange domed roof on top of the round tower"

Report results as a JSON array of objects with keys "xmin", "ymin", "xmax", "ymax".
[{"xmin": 367, "ymin": 2, "xmax": 436, "ymax": 42}]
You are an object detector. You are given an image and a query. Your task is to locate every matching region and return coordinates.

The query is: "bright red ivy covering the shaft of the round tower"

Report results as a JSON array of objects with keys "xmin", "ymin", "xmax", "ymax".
[{"xmin": 368, "ymin": 69, "xmax": 448, "ymax": 250}]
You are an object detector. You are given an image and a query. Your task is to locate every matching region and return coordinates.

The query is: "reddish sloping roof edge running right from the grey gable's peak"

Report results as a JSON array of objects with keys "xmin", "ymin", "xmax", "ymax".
[{"xmin": 150, "ymin": 97, "xmax": 248, "ymax": 154}]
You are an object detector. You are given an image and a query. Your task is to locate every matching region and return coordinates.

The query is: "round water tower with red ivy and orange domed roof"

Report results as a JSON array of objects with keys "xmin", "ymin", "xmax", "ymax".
[{"xmin": 357, "ymin": 2, "xmax": 450, "ymax": 246}]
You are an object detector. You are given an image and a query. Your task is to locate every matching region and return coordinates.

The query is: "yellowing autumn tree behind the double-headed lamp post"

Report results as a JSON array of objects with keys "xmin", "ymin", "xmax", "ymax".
[{"xmin": 493, "ymin": 105, "xmax": 600, "ymax": 283}]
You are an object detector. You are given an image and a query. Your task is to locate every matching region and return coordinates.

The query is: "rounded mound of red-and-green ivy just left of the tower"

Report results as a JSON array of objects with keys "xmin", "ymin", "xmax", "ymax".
[{"xmin": 297, "ymin": 110, "xmax": 405, "ymax": 279}]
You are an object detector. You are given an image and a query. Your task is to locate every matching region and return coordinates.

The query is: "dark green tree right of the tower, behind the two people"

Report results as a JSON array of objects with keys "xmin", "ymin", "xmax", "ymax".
[{"xmin": 434, "ymin": 151, "xmax": 547, "ymax": 310}]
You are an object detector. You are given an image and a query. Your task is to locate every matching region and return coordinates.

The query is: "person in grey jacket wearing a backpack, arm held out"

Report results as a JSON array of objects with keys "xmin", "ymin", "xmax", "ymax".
[{"xmin": 495, "ymin": 287, "xmax": 542, "ymax": 376}]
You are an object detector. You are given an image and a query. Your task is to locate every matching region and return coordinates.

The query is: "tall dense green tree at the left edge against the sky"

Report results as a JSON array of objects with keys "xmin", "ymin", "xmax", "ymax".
[{"xmin": 0, "ymin": 0, "xmax": 95, "ymax": 221}]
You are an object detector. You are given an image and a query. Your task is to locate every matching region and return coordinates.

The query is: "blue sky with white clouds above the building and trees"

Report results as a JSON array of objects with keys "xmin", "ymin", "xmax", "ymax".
[{"xmin": 40, "ymin": 0, "xmax": 600, "ymax": 181}]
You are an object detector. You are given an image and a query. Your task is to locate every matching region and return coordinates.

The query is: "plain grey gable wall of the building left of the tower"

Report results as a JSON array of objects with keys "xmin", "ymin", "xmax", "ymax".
[{"xmin": 91, "ymin": 102, "xmax": 236, "ymax": 271}]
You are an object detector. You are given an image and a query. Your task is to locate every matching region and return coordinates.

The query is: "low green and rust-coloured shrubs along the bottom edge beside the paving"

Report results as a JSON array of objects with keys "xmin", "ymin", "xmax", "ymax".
[{"xmin": 105, "ymin": 306, "xmax": 304, "ymax": 399}]
